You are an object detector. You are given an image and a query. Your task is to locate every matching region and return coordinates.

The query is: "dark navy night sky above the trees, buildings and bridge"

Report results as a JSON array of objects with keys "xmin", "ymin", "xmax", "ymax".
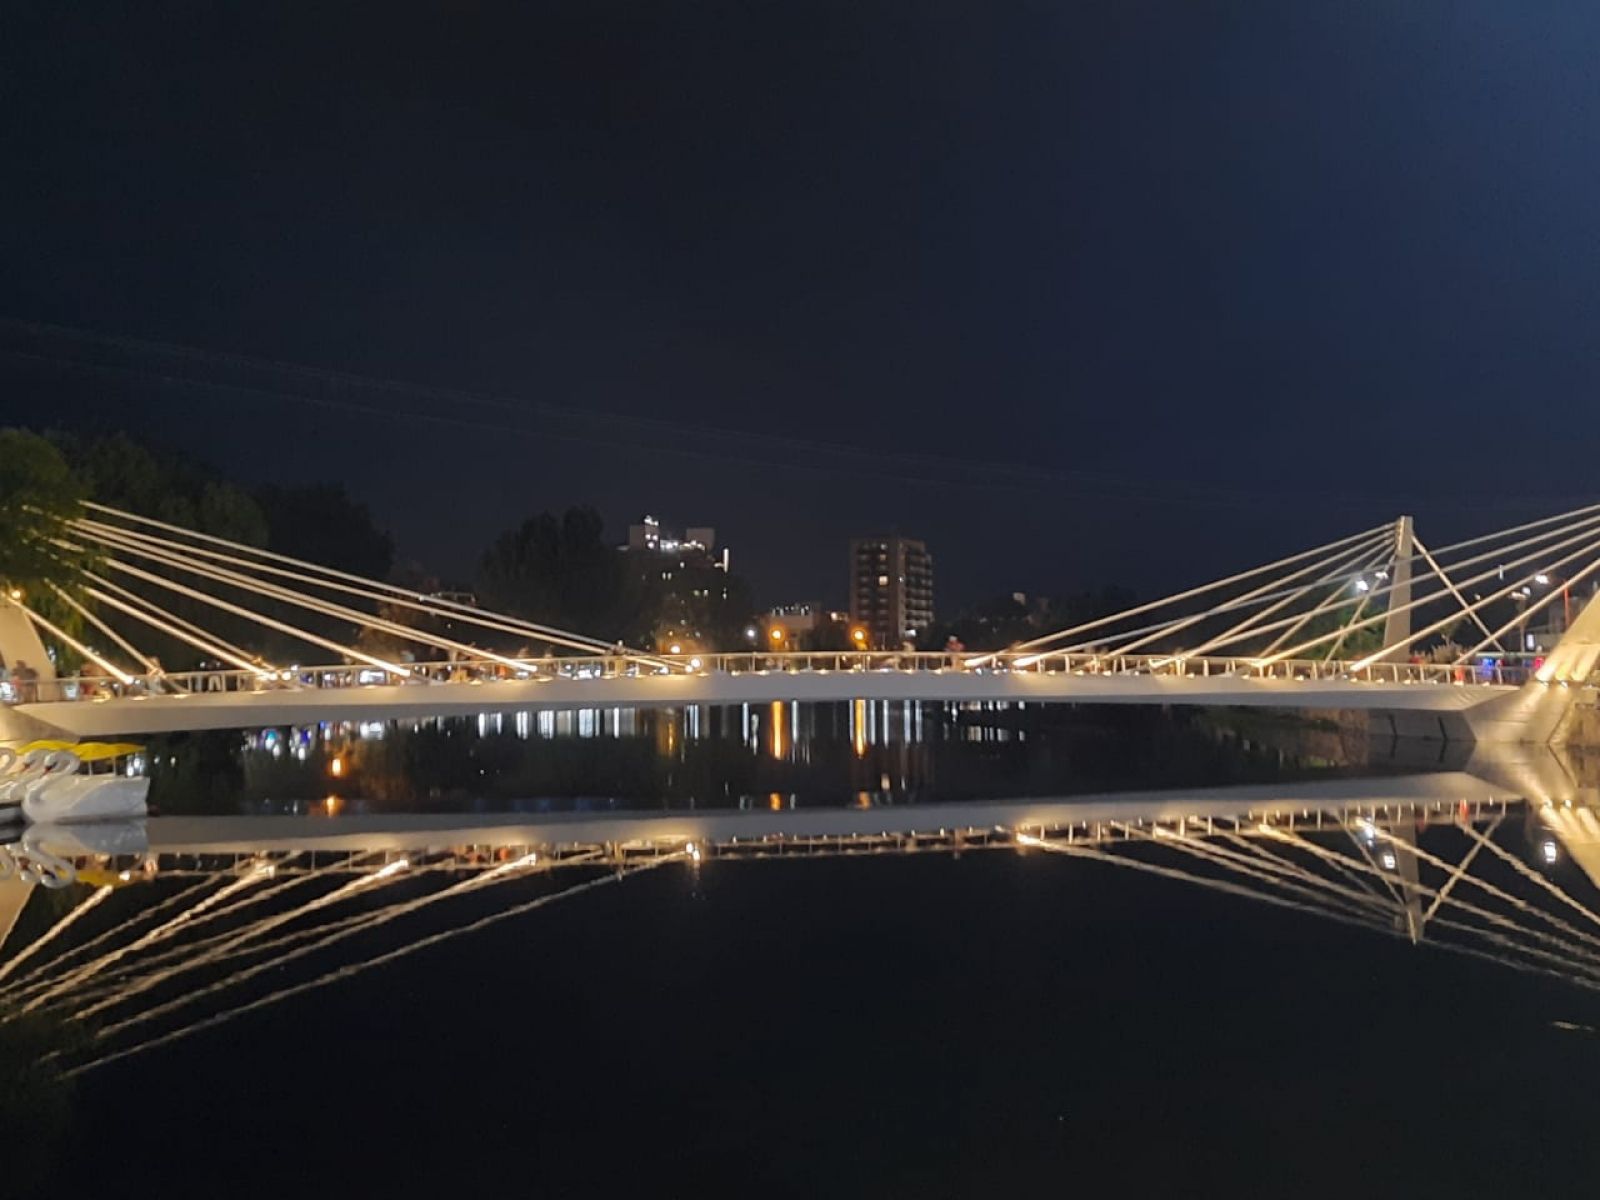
[{"xmin": 0, "ymin": 0, "xmax": 1600, "ymax": 613}]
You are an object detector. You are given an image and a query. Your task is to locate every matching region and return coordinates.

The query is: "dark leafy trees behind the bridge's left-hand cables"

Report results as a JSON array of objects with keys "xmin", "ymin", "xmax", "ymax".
[{"xmin": 0, "ymin": 429, "xmax": 754, "ymax": 669}]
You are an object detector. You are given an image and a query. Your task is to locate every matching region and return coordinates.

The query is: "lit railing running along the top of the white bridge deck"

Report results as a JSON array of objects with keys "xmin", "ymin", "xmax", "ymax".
[{"xmin": 0, "ymin": 651, "xmax": 1534, "ymax": 704}]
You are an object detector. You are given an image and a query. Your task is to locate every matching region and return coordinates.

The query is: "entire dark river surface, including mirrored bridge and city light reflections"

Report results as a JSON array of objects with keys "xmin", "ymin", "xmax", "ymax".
[{"xmin": 0, "ymin": 706, "xmax": 1600, "ymax": 1197}]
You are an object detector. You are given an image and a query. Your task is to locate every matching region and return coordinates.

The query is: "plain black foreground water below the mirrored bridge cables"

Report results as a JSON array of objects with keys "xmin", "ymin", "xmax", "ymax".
[{"xmin": 53, "ymin": 858, "xmax": 1600, "ymax": 1197}]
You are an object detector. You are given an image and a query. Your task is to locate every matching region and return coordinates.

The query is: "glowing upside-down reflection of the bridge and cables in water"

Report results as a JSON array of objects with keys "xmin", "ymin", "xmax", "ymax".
[{"xmin": 9, "ymin": 762, "xmax": 1600, "ymax": 1075}]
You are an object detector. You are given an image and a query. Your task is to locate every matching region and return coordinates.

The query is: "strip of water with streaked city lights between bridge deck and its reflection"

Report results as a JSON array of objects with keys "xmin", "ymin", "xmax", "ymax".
[{"xmin": 150, "ymin": 701, "xmax": 1382, "ymax": 813}]
